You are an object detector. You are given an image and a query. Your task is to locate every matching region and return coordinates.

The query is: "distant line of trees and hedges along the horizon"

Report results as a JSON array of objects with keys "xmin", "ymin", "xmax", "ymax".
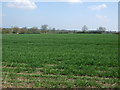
[{"xmin": 1, "ymin": 25, "xmax": 119, "ymax": 34}]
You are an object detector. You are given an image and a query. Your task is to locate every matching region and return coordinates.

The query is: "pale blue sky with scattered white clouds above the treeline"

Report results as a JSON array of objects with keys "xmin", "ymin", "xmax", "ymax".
[{"xmin": 0, "ymin": 0, "xmax": 118, "ymax": 31}]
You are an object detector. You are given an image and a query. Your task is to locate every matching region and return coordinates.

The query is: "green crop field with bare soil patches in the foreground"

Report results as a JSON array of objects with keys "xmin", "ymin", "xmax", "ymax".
[{"xmin": 2, "ymin": 34, "xmax": 119, "ymax": 88}]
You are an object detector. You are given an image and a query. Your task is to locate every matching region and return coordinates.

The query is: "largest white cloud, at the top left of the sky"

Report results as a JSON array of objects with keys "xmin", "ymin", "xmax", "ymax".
[{"xmin": 7, "ymin": 0, "xmax": 37, "ymax": 10}]
